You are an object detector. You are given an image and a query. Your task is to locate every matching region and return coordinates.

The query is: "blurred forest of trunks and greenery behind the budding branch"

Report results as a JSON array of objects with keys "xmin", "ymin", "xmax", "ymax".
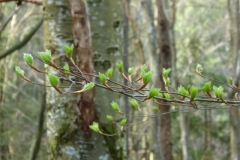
[{"xmin": 0, "ymin": 0, "xmax": 240, "ymax": 160}]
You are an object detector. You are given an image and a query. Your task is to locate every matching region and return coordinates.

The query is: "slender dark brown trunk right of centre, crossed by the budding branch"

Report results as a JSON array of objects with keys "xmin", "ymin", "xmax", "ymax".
[{"xmin": 157, "ymin": 0, "xmax": 173, "ymax": 160}]
